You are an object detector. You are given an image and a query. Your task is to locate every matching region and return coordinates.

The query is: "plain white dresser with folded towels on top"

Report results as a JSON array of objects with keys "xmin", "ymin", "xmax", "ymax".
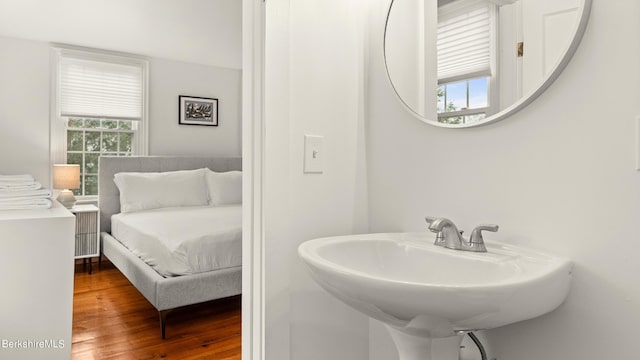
[{"xmin": 0, "ymin": 203, "xmax": 75, "ymax": 360}]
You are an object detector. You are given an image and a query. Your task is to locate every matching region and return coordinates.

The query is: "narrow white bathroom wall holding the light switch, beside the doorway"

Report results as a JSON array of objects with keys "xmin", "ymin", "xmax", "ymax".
[{"xmin": 263, "ymin": 0, "xmax": 368, "ymax": 360}]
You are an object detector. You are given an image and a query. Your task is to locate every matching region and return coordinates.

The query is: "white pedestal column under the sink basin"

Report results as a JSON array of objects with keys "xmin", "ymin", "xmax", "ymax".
[{"xmin": 385, "ymin": 325, "xmax": 463, "ymax": 360}]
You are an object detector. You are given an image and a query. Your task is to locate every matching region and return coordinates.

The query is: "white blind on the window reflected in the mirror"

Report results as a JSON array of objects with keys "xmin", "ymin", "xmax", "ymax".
[{"xmin": 437, "ymin": 0, "xmax": 491, "ymax": 80}]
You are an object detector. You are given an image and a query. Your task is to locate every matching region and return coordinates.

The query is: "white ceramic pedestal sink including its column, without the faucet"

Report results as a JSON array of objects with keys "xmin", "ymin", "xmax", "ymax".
[{"xmin": 298, "ymin": 233, "xmax": 572, "ymax": 360}]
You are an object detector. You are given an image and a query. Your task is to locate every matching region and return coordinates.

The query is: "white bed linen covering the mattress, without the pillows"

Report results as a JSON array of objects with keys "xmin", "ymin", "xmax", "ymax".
[{"xmin": 111, "ymin": 205, "xmax": 242, "ymax": 276}]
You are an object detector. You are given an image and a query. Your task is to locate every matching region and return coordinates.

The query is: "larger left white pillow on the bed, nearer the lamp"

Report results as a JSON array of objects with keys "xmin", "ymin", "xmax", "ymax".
[{"xmin": 114, "ymin": 168, "xmax": 209, "ymax": 213}]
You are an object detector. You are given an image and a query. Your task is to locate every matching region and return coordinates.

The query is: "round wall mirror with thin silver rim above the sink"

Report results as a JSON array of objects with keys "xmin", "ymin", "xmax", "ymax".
[{"xmin": 384, "ymin": 0, "xmax": 591, "ymax": 128}]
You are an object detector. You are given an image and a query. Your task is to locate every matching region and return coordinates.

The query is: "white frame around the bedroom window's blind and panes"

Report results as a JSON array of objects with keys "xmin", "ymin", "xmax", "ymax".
[{"xmin": 49, "ymin": 44, "xmax": 149, "ymax": 202}]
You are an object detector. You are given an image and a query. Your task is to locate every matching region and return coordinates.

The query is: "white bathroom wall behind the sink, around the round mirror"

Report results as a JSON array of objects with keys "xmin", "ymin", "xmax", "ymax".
[{"xmin": 367, "ymin": 0, "xmax": 640, "ymax": 360}]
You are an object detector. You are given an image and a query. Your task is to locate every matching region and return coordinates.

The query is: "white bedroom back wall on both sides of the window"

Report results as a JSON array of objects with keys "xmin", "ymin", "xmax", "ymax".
[{"xmin": 0, "ymin": 36, "xmax": 241, "ymax": 186}]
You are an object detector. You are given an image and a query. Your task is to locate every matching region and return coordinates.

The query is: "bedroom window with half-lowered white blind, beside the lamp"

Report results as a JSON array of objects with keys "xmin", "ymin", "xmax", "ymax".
[{"xmin": 51, "ymin": 48, "xmax": 147, "ymax": 198}]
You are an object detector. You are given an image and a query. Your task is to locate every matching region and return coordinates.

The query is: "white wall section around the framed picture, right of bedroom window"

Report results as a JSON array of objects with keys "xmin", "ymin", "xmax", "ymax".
[{"xmin": 149, "ymin": 59, "xmax": 242, "ymax": 156}]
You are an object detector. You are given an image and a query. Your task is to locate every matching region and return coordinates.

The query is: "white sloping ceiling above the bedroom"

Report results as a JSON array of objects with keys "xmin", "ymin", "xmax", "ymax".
[{"xmin": 0, "ymin": 0, "xmax": 242, "ymax": 69}]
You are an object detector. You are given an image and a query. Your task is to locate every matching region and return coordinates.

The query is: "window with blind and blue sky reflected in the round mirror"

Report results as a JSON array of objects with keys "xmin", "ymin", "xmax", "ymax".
[{"xmin": 437, "ymin": 0, "xmax": 497, "ymax": 124}]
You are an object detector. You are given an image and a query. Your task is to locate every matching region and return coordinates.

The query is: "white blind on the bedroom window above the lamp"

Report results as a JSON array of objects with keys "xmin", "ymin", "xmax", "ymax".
[{"xmin": 59, "ymin": 56, "xmax": 143, "ymax": 120}]
